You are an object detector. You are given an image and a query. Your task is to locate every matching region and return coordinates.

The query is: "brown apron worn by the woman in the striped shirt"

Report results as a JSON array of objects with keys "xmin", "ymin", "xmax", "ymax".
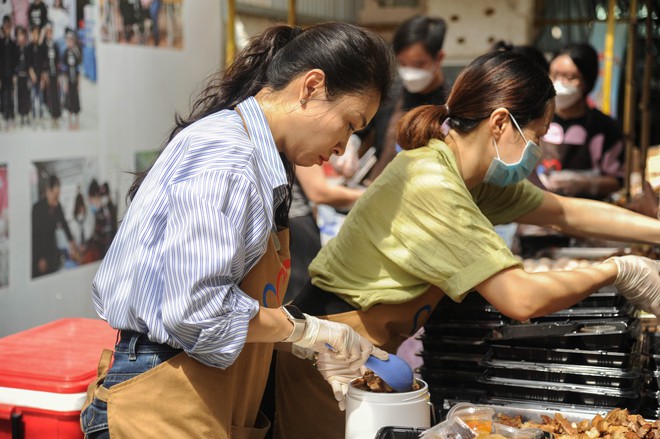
[{"xmin": 88, "ymin": 229, "xmax": 291, "ymax": 439}]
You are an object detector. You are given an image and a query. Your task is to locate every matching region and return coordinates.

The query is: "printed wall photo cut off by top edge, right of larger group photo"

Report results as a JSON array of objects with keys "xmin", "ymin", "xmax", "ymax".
[{"xmin": 98, "ymin": 0, "xmax": 183, "ymax": 49}]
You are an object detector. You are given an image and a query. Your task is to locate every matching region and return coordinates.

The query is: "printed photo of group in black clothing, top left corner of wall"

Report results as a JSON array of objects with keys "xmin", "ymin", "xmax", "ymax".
[{"xmin": 0, "ymin": 0, "xmax": 98, "ymax": 131}]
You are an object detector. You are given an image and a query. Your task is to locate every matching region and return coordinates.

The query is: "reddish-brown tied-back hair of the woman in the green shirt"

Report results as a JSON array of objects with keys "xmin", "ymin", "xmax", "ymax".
[{"xmin": 397, "ymin": 51, "xmax": 555, "ymax": 149}]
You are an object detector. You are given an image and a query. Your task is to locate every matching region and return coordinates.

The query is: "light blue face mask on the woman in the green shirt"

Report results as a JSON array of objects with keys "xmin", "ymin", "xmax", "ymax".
[{"xmin": 484, "ymin": 113, "xmax": 541, "ymax": 187}]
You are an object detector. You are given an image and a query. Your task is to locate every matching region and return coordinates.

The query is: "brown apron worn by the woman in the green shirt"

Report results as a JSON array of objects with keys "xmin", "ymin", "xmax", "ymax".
[{"xmin": 273, "ymin": 286, "xmax": 444, "ymax": 439}]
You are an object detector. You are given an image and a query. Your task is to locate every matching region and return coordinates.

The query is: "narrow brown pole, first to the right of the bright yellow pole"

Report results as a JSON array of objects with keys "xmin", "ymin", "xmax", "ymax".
[{"xmin": 623, "ymin": 0, "xmax": 637, "ymax": 200}]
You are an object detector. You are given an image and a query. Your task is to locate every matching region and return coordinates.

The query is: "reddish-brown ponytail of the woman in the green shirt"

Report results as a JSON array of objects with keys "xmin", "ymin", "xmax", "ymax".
[{"xmin": 397, "ymin": 105, "xmax": 449, "ymax": 149}]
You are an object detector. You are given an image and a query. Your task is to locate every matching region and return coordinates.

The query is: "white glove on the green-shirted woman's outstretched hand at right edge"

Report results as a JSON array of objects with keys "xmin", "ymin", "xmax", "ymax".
[{"xmin": 605, "ymin": 255, "xmax": 660, "ymax": 316}]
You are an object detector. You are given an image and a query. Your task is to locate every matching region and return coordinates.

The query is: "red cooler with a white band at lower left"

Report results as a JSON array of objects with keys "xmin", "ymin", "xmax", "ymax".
[{"xmin": 0, "ymin": 318, "xmax": 117, "ymax": 439}]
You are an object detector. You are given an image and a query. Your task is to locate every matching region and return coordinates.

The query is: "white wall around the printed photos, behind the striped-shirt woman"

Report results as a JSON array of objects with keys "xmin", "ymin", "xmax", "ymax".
[{"xmin": 0, "ymin": 0, "xmax": 223, "ymax": 337}]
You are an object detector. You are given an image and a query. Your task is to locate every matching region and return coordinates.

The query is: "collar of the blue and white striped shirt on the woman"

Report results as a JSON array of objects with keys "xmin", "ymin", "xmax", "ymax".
[{"xmin": 236, "ymin": 96, "xmax": 289, "ymax": 189}]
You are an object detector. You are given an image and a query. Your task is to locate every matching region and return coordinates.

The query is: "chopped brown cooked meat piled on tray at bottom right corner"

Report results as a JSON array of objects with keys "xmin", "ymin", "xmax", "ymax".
[{"xmin": 496, "ymin": 409, "xmax": 660, "ymax": 439}]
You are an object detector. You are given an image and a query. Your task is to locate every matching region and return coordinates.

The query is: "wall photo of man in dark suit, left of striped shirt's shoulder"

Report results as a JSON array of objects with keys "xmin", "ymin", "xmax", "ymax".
[{"xmin": 30, "ymin": 158, "xmax": 117, "ymax": 278}]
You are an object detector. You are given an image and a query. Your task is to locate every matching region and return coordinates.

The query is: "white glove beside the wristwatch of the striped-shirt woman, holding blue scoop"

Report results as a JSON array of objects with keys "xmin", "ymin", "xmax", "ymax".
[{"xmin": 293, "ymin": 314, "xmax": 374, "ymax": 367}]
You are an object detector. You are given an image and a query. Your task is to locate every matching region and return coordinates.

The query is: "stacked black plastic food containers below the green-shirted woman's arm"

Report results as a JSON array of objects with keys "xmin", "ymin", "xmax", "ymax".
[{"xmin": 420, "ymin": 287, "xmax": 640, "ymax": 419}]
